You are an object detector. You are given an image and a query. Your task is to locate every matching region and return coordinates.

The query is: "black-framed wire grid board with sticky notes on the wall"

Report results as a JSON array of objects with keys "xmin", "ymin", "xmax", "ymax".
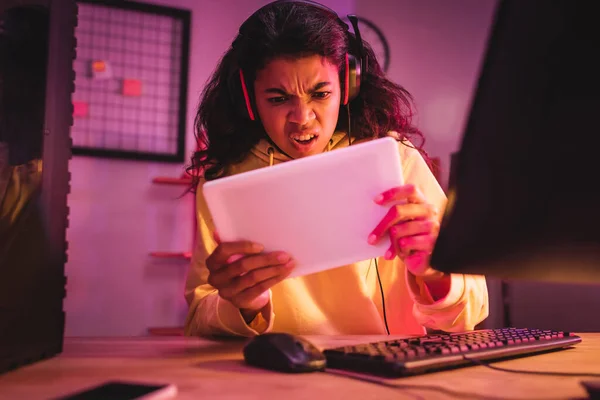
[{"xmin": 71, "ymin": 0, "xmax": 191, "ymax": 162}]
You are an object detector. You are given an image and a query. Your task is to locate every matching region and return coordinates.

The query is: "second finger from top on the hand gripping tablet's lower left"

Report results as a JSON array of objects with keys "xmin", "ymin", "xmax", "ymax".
[{"xmin": 208, "ymin": 252, "xmax": 290, "ymax": 289}]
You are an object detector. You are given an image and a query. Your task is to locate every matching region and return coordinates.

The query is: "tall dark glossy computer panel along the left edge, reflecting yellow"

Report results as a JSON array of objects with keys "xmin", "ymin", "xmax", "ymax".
[{"xmin": 0, "ymin": 0, "xmax": 77, "ymax": 373}]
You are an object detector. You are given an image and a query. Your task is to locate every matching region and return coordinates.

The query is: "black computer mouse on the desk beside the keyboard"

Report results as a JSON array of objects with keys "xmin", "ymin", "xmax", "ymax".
[{"xmin": 244, "ymin": 332, "xmax": 326, "ymax": 372}]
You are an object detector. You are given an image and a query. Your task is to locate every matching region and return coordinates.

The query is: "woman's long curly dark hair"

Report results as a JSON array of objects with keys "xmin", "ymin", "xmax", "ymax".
[{"xmin": 187, "ymin": 1, "xmax": 428, "ymax": 190}]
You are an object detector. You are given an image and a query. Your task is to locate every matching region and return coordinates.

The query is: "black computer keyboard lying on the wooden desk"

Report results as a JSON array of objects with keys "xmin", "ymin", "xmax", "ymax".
[{"xmin": 323, "ymin": 328, "xmax": 581, "ymax": 377}]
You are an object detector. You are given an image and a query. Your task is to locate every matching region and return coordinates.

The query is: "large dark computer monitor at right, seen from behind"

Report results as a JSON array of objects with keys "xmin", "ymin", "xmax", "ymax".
[{"xmin": 431, "ymin": 0, "xmax": 600, "ymax": 283}]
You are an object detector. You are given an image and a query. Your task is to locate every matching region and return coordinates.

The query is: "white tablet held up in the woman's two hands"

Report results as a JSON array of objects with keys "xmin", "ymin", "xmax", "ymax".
[{"xmin": 203, "ymin": 137, "xmax": 403, "ymax": 277}]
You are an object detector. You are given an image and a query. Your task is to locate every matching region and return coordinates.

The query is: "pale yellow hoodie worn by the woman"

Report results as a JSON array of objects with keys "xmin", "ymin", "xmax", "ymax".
[{"xmin": 185, "ymin": 133, "xmax": 488, "ymax": 336}]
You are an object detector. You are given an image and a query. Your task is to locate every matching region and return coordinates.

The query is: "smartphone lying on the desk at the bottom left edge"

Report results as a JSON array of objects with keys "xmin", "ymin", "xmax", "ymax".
[{"xmin": 55, "ymin": 381, "xmax": 177, "ymax": 400}]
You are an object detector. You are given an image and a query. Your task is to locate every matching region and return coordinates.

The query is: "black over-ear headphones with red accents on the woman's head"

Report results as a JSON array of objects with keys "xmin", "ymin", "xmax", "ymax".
[{"xmin": 227, "ymin": 0, "xmax": 367, "ymax": 121}]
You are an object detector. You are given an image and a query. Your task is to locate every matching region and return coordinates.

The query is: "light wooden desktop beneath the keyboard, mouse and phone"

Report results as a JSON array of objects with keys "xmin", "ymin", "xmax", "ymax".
[{"xmin": 0, "ymin": 333, "xmax": 600, "ymax": 400}]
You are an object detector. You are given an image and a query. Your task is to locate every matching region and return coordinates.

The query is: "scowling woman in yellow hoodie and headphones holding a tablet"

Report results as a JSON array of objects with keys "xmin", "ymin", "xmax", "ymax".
[{"xmin": 185, "ymin": 1, "xmax": 488, "ymax": 336}]
